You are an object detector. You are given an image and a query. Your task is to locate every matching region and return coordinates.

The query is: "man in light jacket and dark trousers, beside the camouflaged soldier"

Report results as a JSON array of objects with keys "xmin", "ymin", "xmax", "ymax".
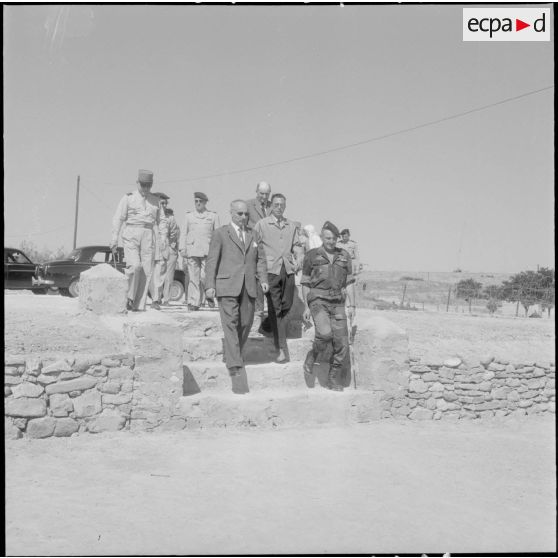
[{"xmin": 254, "ymin": 194, "xmax": 304, "ymax": 362}]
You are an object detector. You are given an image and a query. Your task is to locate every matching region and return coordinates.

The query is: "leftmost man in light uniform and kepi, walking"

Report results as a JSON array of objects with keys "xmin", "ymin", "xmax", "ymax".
[{"xmin": 110, "ymin": 169, "xmax": 160, "ymax": 311}]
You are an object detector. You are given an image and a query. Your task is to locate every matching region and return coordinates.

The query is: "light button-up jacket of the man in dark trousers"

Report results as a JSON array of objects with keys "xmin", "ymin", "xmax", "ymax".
[{"xmin": 254, "ymin": 215, "xmax": 304, "ymax": 275}]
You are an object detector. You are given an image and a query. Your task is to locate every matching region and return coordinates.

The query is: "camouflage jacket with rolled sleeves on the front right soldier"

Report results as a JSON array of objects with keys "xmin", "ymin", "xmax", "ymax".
[{"xmin": 300, "ymin": 246, "xmax": 354, "ymax": 303}]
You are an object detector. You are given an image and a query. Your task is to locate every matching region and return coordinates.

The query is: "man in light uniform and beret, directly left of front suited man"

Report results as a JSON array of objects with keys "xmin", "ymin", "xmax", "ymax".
[{"xmin": 180, "ymin": 192, "xmax": 221, "ymax": 310}]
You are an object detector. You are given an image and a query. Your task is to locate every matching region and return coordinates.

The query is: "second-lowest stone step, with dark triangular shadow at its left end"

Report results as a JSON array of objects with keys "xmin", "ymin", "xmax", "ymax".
[{"xmin": 183, "ymin": 361, "xmax": 351, "ymax": 395}]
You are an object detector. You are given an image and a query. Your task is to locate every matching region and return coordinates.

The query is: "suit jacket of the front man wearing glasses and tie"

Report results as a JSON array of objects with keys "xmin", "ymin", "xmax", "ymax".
[{"xmin": 205, "ymin": 225, "xmax": 267, "ymax": 298}]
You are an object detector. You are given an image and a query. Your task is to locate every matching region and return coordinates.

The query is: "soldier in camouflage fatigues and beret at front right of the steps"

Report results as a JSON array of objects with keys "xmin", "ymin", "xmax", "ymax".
[{"xmin": 301, "ymin": 221, "xmax": 355, "ymax": 391}]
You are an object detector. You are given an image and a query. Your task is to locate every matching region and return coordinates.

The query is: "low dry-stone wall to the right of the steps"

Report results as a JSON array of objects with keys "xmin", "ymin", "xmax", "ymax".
[{"xmin": 390, "ymin": 356, "xmax": 556, "ymax": 420}]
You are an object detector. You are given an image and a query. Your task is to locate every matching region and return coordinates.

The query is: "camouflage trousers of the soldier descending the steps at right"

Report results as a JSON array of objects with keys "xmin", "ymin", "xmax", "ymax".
[{"xmin": 308, "ymin": 298, "xmax": 349, "ymax": 368}]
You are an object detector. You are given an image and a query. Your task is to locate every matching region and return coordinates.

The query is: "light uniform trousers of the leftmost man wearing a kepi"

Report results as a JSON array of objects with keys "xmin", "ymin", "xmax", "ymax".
[{"xmin": 122, "ymin": 225, "xmax": 155, "ymax": 310}]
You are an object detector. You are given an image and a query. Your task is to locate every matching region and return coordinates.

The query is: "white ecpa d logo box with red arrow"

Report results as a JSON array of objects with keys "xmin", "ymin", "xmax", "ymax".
[{"xmin": 463, "ymin": 8, "xmax": 552, "ymax": 41}]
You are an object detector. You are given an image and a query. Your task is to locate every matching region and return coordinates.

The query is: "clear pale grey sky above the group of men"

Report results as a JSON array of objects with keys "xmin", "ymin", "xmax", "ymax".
[{"xmin": 3, "ymin": 4, "xmax": 554, "ymax": 272}]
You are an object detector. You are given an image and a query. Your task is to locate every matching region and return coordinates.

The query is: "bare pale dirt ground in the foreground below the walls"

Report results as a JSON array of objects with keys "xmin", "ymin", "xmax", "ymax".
[{"xmin": 6, "ymin": 417, "xmax": 556, "ymax": 555}]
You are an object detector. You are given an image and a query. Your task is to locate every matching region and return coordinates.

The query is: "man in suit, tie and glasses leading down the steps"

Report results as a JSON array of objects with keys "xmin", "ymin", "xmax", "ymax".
[{"xmin": 205, "ymin": 200, "xmax": 268, "ymax": 393}]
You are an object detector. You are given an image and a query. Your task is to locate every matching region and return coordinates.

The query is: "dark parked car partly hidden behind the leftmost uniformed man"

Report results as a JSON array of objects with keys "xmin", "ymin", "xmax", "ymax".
[{"xmin": 33, "ymin": 246, "xmax": 186, "ymax": 301}]
